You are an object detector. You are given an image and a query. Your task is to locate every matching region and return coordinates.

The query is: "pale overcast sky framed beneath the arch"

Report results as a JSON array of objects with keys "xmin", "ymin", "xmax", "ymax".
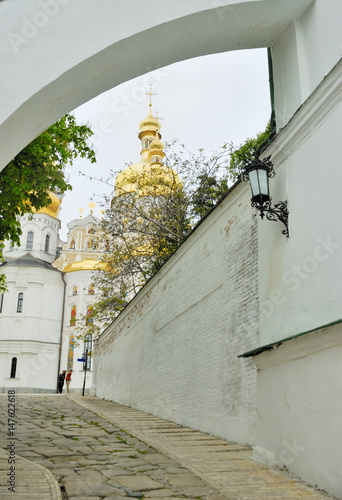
[{"xmin": 60, "ymin": 49, "xmax": 271, "ymax": 241}]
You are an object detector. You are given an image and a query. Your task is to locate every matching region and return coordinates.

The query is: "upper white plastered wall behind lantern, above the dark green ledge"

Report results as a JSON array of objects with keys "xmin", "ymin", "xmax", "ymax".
[{"xmin": 259, "ymin": 58, "xmax": 342, "ymax": 345}]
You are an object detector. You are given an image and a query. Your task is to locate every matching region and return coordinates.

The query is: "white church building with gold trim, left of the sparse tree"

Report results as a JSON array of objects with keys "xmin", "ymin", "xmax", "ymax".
[{"xmin": 0, "ymin": 193, "xmax": 103, "ymax": 393}]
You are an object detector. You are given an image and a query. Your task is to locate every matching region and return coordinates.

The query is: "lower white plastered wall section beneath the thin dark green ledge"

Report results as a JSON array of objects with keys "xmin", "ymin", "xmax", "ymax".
[{"xmin": 254, "ymin": 324, "xmax": 342, "ymax": 498}]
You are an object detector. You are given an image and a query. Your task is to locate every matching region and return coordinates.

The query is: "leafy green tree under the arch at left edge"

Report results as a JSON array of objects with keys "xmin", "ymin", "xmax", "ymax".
[{"xmin": 0, "ymin": 115, "xmax": 96, "ymax": 291}]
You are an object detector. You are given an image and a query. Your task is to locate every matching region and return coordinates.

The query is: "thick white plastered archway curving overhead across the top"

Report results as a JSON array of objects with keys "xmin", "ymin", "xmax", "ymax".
[{"xmin": 0, "ymin": 0, "xmax": 313, "ymax": 169}]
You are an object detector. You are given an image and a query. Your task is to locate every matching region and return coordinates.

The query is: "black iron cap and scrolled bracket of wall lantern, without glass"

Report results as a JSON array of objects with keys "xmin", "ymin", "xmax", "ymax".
[{"xmin": 241, "ymin": 156, "xmax": 289, "ymax": 237}]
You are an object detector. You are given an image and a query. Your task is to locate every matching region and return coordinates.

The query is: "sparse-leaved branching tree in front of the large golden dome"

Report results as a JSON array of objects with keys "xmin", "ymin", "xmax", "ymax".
[{"xmin": 80, "ymin": 168, "xmax": 191, "ymax": 336}]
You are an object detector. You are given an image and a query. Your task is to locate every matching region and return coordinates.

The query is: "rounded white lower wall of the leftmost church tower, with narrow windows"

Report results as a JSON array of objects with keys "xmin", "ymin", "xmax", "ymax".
[{"xmin": 0, "ymin": 266, "xmax": 64, "ymax": 392}]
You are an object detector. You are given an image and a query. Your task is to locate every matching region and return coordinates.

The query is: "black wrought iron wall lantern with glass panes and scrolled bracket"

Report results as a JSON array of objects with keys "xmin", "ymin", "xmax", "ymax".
[{"xmin": 241, "ymin": 156, "xmax": 289, "ymax": 237}]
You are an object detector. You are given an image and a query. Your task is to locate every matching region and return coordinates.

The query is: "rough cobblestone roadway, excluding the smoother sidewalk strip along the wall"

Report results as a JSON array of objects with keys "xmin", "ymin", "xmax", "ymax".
[{"xmin": 0, "ymin": 394, "xmax": 227, "ymax": 500}]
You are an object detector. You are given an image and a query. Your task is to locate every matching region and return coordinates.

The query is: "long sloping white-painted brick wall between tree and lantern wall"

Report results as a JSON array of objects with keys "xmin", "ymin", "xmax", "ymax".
[{"xmin": 94, "ymin": 183, "xmax": 259, "ymax": 443}]
